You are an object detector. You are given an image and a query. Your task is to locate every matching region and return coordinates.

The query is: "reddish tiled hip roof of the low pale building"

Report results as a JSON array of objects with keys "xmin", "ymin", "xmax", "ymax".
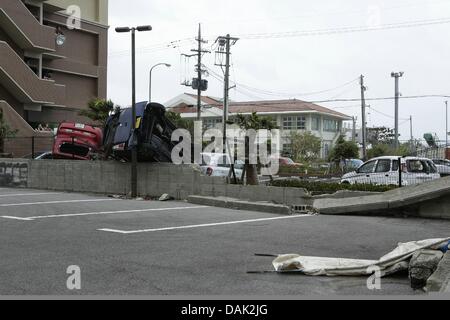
[{"xmin": 167, "ymin": 94, "xmax": 351, "ymax": 120}]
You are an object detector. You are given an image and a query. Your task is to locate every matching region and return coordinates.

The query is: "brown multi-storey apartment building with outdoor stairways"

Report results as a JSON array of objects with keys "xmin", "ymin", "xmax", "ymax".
[{"xmin": 0, "ymin": 0, "xmax": 108, "ymax": 137}]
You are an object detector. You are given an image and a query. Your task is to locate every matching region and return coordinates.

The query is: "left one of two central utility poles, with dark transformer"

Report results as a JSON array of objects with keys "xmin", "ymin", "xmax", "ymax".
[{"xmin": 182, "ymin": 23, "xmax": 210, "ymax": 121}]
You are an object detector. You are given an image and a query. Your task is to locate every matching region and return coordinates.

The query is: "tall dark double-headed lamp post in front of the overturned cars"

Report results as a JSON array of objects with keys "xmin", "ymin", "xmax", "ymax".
[{"xmin": 116, "ymin": 26, "xmax": 152, "ymax": 198}]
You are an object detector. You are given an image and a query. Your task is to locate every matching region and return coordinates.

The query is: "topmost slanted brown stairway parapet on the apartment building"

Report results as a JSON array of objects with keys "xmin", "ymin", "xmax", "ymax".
[{"xmin": 0, "ymin": 0, "xmax": 56, "ymax": 52}]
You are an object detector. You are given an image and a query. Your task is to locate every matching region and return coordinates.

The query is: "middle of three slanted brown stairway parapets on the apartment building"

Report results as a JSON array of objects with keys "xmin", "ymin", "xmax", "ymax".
[{"xmin": 0, "ymin": 41, "xmax": 66, "ymax": 106}]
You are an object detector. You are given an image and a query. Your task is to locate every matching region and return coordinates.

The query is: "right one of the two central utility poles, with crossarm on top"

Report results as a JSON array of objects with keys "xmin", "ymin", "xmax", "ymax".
[{"xmin": 216, "ymin": 34, "xmax": 239, "ymax": 153}]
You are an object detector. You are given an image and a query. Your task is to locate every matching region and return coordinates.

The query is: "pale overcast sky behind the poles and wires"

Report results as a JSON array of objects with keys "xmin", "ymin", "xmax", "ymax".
[{"xmin": 108, "ymin": 0, "xmax": 450, "ymax": 140}]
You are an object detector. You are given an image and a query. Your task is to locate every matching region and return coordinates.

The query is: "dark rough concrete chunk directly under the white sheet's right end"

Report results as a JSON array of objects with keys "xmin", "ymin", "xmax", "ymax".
[{"xmin": 409, "ymin": 250, "xmax": 444, "ymax": 289}]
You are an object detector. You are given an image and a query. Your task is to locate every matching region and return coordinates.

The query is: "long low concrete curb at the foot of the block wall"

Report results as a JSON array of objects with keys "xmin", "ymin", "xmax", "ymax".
[{"xmin": 188, "ymin": 196, "xmax": 291, "ymax": 215}]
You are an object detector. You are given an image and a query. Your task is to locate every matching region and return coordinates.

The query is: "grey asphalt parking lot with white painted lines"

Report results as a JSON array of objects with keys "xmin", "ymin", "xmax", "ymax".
[{"xmin": 0, "ymin": 188, "xmax": 450, "ymax": 295}]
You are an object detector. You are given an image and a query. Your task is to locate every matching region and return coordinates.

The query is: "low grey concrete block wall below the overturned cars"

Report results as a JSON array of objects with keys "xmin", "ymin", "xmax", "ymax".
[{"xmin": 0, "ymin": 159, "xmax": 312, "ymax": 206}]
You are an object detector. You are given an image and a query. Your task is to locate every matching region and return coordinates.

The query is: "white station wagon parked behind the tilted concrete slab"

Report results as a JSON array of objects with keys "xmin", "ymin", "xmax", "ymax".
[{"xmin": 341, "ymin": 156, "xmax": 441, "ymax": 186}]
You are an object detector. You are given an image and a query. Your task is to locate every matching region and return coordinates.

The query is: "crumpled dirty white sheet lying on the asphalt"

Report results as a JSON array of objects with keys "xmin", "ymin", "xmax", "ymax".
[{"xmin": 272, "ymin": 238, "xmax": 450, "ymax": 277}]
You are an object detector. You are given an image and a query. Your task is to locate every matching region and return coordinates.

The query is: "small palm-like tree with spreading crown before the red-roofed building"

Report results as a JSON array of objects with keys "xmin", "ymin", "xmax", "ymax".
[{"xmin": 230, "ymin": 112, "xmax": 278, "ymax": 185}]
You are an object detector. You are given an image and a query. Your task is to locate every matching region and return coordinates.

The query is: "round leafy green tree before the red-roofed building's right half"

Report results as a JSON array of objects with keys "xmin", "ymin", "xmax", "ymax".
[{"xmin": 290, "ymin": 131, "xmax": 322, "ymax": 162}]
